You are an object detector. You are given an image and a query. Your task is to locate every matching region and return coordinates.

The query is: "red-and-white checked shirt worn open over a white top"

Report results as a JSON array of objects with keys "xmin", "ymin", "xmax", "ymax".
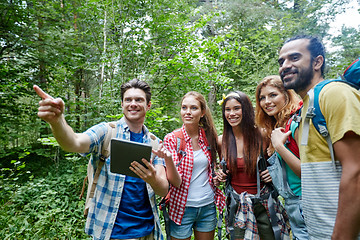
[{"xmin": 164, "ymin": 126, "xmax": 225, "ymax": 225}]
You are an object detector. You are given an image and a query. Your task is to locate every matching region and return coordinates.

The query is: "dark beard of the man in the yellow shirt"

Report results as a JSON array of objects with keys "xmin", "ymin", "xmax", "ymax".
[{"xmin": 281, "ymin": 63, "xmax": 314, "ymax": 93}]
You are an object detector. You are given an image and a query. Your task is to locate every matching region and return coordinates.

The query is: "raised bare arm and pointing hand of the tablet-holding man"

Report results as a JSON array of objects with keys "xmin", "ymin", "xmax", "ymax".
[{"xmin": 34, "ymin": 85, "xmax": 90, "ymax": 153}]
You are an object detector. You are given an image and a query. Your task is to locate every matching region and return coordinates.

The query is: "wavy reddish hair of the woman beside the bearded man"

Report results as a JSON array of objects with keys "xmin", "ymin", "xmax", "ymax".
[{"xmin": 255, "ymin": 75, "xmax": 301, "ymax": 152}]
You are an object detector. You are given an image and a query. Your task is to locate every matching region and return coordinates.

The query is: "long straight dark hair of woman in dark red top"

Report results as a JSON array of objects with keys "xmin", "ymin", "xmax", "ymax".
[{"xmin": 221, "ymin": 91, "xmax": 261, "ymax": 175}]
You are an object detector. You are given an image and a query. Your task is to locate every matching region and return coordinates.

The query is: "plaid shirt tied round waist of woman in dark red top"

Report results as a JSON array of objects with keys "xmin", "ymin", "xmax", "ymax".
[{"xmin": 231, "ymin": 187, "xmax": 290, "ymax": 240}]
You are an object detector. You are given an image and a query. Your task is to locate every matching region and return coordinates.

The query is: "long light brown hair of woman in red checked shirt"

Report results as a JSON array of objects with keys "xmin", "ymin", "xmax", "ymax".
[{"xmin": 181, "ymin": 91, "xmax": 218, "ymax": 164}]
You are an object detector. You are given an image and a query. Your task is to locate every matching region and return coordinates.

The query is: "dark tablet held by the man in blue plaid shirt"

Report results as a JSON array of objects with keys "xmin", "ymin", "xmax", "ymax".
[{"xmin": 110, "ymin": 138, "xmax": 152, "ymax": 178}]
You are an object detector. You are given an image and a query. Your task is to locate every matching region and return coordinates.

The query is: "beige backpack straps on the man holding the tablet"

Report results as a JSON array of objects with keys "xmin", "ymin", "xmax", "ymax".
[{"xmin": 79, "ymin": 122, "xmax": 159, "ymax": 217}]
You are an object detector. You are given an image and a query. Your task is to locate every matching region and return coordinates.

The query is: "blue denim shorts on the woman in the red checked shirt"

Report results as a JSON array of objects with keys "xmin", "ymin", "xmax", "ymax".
[{"xmin": 170, "ymin": 203, "xmax": 217, "ymax": 239}]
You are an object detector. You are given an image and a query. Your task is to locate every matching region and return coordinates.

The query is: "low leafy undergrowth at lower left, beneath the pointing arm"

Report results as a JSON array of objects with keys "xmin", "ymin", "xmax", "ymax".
[{"xmin": 0, "ymin": 149, "xmax": 226, "ymax": 240}]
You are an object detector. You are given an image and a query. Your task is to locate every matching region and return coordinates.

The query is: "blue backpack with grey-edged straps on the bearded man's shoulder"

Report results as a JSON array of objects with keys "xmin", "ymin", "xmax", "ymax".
[{"xmin": 301, "ymin": 58, "xmax": 360, "ymax": 168}]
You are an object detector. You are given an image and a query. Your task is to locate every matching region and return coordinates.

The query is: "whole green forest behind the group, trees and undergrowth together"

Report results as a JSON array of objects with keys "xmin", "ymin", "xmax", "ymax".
[{"xmin": 0, "ymin": 0, "xmax": 360, "ymax": 239}]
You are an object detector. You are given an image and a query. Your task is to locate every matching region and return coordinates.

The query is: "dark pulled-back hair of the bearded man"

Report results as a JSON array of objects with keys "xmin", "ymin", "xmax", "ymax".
[{"xmin": 284, "ymin": 35, "xmax": 325, "ymax": 77}]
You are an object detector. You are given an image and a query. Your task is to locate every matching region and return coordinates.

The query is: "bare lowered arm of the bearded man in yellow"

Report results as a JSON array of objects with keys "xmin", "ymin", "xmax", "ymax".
[{"xmin": 332, "ymin": 132, "xmax": 360, "ymax": 240}]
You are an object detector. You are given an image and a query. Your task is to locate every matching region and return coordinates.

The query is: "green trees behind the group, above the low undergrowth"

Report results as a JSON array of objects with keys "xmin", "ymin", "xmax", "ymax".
[{"xmin": 0, "ymin": 0, "xmax": 356, "ymax": 150}]
